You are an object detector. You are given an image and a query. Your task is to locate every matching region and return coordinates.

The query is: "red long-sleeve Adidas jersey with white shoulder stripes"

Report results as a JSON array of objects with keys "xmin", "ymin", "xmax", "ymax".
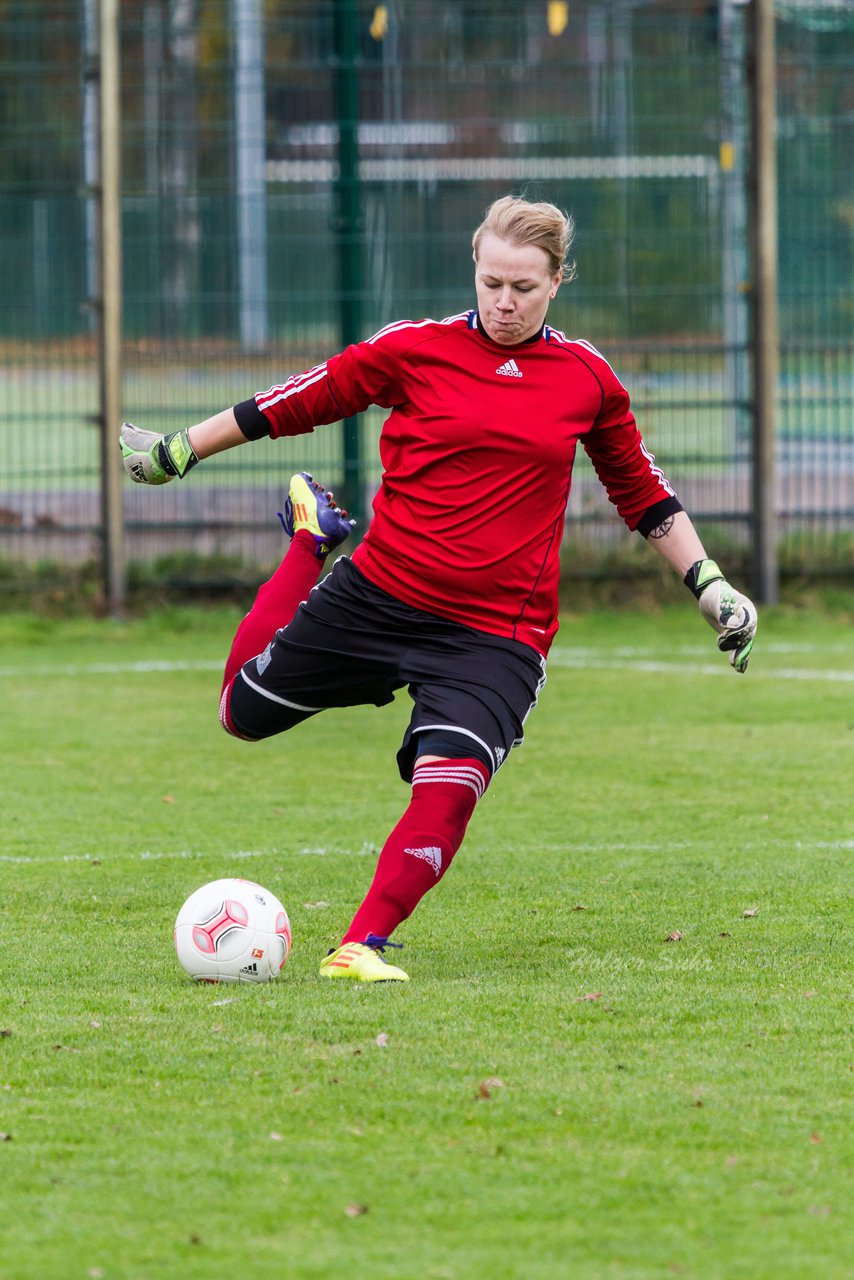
[{"xmin": 238, "ymin": 311, "xmax": 679, "ymax": 654}]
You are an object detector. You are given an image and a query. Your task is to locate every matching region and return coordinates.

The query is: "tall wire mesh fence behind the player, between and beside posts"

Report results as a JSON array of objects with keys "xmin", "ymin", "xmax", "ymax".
[{"xmin": 0, "ymin": 0, "xmax": 854, "ymax": 604}]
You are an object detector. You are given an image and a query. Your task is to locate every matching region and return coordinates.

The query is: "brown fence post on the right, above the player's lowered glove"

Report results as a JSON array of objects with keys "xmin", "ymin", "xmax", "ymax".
[{"xmin": 749, "ymin": 0, "xmax": 780, "ymax": 604}]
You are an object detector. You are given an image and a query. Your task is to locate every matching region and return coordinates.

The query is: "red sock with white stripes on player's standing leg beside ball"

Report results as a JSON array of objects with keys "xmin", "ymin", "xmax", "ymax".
[{"xmin": 343, "ymin": 760, "xmax": 489, "ymax": 942}]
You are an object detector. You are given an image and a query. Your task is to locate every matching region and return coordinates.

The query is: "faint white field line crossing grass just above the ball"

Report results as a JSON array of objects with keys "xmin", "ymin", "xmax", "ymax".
[{"xmin": 0, "ymin": 838, "xmax": 854, "ymax": 865}]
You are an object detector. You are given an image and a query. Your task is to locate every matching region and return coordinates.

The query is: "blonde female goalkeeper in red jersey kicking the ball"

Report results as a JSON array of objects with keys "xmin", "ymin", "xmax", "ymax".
[{"xmin": 122, "ymin": 196, "xmax": 757, "ymax": 982}]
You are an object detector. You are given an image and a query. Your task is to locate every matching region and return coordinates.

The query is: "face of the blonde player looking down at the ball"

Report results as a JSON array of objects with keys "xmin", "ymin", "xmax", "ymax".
[{"xmin": 475, "ymin": 236, "xmax": 561, "ymax": 347}]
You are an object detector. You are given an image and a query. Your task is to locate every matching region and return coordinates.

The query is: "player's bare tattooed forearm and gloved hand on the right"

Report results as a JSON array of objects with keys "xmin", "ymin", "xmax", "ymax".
[{"xmin": 649, "ymin": 511, "xmax": 757, "ymax": 675}]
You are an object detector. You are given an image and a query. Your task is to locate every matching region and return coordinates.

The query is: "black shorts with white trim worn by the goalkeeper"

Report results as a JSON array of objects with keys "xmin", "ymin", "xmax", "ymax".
[{"xmin": 229, "ymin": 558, "xmax": 545, "ymax": 782}]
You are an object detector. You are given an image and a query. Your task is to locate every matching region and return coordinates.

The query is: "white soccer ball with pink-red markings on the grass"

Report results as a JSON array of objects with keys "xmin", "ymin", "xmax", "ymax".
[{"xmin": 175, "ymin": 879, "xmax": 291, "ymax": 982}]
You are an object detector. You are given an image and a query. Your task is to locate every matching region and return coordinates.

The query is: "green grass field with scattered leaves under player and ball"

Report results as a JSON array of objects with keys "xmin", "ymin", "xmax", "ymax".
[{"xmin": 0, "ymin": 604, "xmax": 854, "ymax": 1280}]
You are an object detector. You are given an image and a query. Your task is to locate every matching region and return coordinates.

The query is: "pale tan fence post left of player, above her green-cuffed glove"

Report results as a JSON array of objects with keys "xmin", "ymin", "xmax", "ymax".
[{"xmin": 96, "ymin": 0, "xmax": 125, "ymax": 617}]
